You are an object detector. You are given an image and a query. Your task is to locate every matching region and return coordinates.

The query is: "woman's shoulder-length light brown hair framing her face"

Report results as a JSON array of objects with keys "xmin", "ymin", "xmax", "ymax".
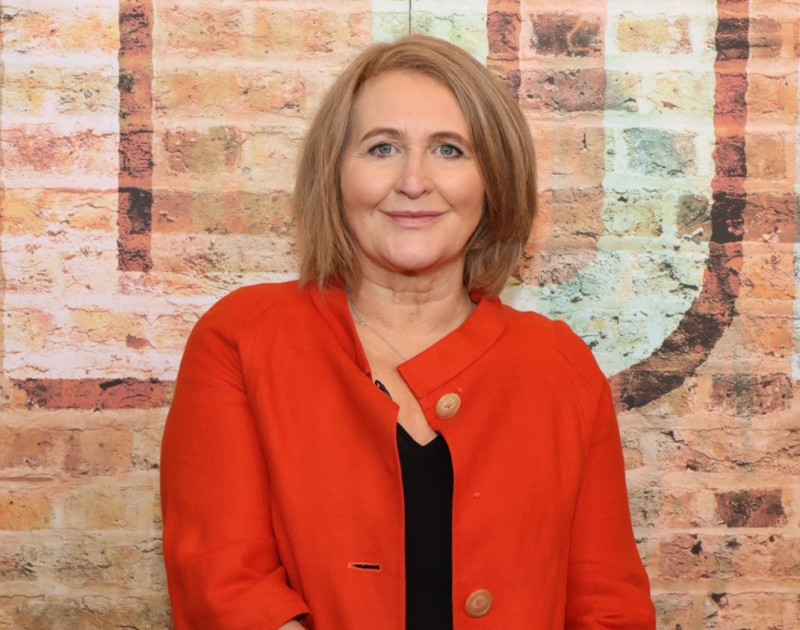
[{"xmin": 294, "ymin": 35, "xmax": 536, "ymax": 296}]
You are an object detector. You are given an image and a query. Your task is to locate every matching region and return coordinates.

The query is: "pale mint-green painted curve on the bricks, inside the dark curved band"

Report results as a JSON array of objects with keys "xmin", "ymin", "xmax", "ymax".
[{"xmin": 503, "ymin": 0, "xmax": 714, "ymax": 375}]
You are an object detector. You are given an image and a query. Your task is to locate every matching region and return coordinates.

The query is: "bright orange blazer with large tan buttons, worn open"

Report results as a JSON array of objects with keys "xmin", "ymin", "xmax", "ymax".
[{"xmin": 161, "ymin": 283, "xmax": 655, "ymax": 630}]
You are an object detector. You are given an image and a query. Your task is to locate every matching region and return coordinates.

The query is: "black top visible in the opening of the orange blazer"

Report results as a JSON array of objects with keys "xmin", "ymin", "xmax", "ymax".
[{"xmin": 397, "ymin": 424, "xmax": 453, "ymax": 630}]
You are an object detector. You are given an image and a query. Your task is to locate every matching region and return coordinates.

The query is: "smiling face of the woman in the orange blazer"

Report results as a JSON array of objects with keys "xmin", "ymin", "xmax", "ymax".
[{"xmin": 339, "ymin": 71, "xmax": 484, "ymax": 286}]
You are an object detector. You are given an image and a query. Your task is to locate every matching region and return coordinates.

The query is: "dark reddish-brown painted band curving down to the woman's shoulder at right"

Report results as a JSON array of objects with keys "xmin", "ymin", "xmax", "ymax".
[{"xmin": 611, "ymin": 0, "xmax": 750, "ymax": 408}]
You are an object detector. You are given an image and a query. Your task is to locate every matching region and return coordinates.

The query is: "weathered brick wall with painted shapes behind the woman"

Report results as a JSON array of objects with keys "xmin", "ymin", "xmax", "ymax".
[{"xmin": 0, "ymin": 0, "xmax": 800, "ymax": 630}]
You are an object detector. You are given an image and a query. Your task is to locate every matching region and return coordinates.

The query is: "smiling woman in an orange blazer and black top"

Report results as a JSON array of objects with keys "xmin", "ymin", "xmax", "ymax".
[{"xmin": 162, "ymin": 36, "xmax": 655, "ymax": 630}]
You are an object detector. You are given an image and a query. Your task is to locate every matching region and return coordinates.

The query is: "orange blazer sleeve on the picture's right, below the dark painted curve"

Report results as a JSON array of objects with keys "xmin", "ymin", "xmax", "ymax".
[{"xmin": 566, "ymin": 336, "xmax": 656, "ymax": 630}]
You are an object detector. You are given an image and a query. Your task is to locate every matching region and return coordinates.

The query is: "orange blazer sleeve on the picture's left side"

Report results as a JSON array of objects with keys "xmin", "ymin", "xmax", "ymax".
[{"xmin": 161, "ymin": 304, "xmax": 309, "ymax": 630}]
